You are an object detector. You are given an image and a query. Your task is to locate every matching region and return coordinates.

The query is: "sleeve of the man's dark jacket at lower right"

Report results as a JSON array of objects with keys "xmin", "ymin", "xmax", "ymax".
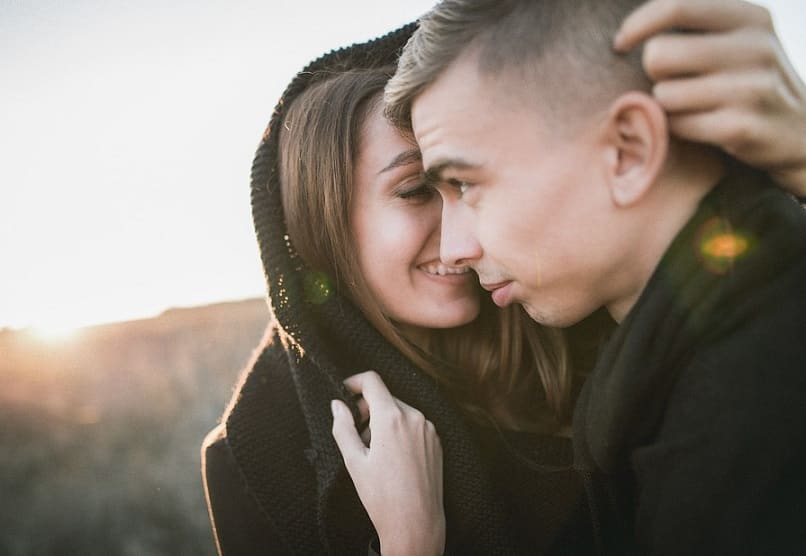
[{"xmin": 632, "ymin": 310, "xmax": 806, "ymax": 555}]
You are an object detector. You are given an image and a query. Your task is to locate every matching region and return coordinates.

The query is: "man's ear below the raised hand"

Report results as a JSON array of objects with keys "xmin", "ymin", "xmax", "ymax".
[{"xmin": 605, "ymin": 91, "xmax": 669, "ymax": 207}]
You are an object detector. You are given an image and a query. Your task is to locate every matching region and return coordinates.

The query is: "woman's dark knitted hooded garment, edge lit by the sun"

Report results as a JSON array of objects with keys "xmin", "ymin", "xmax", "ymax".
[{"xmin": 202, "ymin": 21, "xmax": 591, "ymax": 555}]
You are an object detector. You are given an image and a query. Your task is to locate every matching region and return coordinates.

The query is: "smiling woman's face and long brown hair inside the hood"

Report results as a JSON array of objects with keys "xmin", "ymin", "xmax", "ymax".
[{"xmin": 279, "ymin": 68, "xmax": 579, "ymax": 549}]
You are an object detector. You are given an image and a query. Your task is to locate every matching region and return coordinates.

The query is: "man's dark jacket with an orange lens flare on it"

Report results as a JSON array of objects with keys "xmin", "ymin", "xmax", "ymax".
[{"xmin": 574, "ymin": 165, "xmax": 806, "ymax": 555}]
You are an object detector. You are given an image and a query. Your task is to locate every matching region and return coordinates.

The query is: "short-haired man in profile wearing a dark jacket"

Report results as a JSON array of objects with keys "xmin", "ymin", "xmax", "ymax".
[{"xmin": 387, "ymin": 0, "xmax": 806, "ymax": 554}]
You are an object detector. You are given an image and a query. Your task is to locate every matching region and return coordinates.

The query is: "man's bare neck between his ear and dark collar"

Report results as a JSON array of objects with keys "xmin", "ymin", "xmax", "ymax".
[{"xmin": 607, "ymin": 144, "xmax": 725, "ymax": 323}]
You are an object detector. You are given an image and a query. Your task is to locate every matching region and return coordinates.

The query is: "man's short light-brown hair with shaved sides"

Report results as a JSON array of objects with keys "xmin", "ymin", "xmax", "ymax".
[{"xmin": 385, "ymin": 0, "xmax": 650, "ymax": 131}]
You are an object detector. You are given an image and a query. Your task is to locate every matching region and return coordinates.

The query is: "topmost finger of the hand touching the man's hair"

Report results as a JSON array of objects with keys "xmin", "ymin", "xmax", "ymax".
[{"xmin": 613, "ymin": 0, "xmax": 772, "ymax": 52}]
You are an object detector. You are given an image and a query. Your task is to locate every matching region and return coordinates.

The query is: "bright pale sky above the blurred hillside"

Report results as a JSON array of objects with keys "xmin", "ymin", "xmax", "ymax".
[{"xmin": 0, "ymin": 0, "xmax": 806, "ymax": 328}]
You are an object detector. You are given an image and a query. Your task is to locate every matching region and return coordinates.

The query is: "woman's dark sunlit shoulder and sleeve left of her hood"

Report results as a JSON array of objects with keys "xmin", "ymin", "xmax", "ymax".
[{"xmin": 202, "ymin": 336, "xmax": 321, "ymax": 554}]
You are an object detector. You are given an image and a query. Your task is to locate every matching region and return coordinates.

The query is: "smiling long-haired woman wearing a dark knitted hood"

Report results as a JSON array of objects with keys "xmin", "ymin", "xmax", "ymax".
[{"xmin": 206, "ymin": 56, "xmax": 590, "ymax": 554}]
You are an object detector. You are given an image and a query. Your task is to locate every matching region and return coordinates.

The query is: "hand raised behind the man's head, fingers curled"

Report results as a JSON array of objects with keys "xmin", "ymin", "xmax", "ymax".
[{"xmin": 614, "ymin": 0, "xmax": 806, "ymax": 197}]
